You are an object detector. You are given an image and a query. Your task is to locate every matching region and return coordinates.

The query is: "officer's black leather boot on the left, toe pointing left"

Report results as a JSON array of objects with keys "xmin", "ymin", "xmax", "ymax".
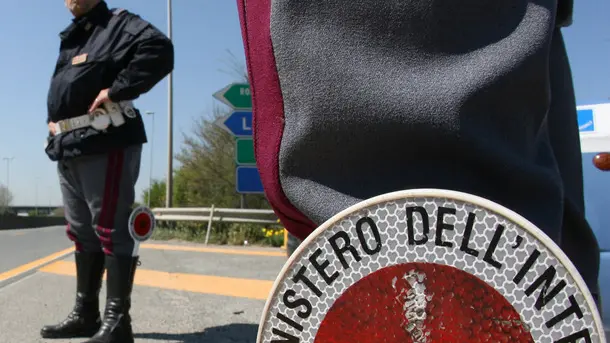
[{"xmin": 40, "ymin": 252, "xmax": 104, "ymax": 338}]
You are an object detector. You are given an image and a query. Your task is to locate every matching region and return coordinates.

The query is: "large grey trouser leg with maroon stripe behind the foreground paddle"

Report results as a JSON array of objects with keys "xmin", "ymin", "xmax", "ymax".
[{"xmin": 237, "ymin": 0, "xmax": 599, "ymax": 310}]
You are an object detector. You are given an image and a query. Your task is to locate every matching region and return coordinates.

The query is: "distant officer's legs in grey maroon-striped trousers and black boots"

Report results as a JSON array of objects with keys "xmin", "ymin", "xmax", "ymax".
[{"xmin": 42, "ymin": 145, "xmax": 142, "ymax": 343}]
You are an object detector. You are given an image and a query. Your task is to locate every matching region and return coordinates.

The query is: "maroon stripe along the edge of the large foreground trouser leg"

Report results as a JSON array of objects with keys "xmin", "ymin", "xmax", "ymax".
[{"xmin": 237, "ymin": 0, "xmax": 316, "ymax": 239}]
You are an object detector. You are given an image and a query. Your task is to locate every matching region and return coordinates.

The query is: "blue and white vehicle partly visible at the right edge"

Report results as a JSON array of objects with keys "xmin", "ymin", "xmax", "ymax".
[{"xmin": 577, "ymin": 103, "xmax": 610, "ymax": 332}]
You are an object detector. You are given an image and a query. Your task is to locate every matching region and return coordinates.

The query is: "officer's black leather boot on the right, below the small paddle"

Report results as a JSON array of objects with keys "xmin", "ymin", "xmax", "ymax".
[{"xmin": 84, "ymin": 255, "xmax": 138, "ymax": 343}]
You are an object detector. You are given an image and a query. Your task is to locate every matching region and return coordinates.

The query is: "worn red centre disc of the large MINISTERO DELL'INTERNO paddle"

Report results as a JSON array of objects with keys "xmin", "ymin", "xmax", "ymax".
[{"xmin": 314, "ymin": 263, "xmax": 534, "ymax": 343}]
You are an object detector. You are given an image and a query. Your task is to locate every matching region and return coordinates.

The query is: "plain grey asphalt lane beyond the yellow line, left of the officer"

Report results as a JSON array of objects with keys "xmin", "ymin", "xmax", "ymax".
[{"xmin": 0, "ymin": 226, "xmax": 73, "ymax": 274}]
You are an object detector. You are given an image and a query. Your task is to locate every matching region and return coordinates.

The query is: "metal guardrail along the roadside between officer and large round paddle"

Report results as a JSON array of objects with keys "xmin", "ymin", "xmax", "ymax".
[{"xmin": 151, "ymin": 205, "xmax": 278, "ymax": 244}]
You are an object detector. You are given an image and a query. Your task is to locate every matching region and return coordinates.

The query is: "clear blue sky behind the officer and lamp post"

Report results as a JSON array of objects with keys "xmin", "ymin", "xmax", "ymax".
[{"xmin": 0, "ymin": 0, "xmax": 610, "ymax": 206}]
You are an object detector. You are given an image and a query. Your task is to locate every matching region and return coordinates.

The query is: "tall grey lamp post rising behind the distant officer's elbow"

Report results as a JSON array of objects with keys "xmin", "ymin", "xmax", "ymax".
[{"xmin": 165, "ymin": 0, "xmax": 174, "ymax": 208}]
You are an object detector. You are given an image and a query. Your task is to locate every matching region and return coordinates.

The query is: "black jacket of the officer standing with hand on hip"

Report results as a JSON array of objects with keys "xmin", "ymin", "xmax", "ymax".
[{"xmin": 45, "ymin": 1, "xmax": 174, "ymax": 161}]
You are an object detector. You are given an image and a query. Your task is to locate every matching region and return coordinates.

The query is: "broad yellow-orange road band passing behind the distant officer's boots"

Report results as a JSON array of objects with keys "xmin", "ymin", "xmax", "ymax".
[{"xmin": 40, "ymin": 261, "xmax": 273, "ymax": 300}]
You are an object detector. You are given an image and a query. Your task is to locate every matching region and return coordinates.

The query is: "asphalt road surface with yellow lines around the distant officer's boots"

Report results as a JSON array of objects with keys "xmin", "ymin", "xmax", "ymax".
[{"xmin": 0, "ymin": 227, "xmax": 286, "ymax": 343}]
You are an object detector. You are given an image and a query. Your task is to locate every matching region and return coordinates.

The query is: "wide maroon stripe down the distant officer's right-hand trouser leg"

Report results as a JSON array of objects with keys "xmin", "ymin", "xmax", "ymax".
[{"xmin": 96, "ymin": 152, "xmax": 123, "ymax": 255}]
